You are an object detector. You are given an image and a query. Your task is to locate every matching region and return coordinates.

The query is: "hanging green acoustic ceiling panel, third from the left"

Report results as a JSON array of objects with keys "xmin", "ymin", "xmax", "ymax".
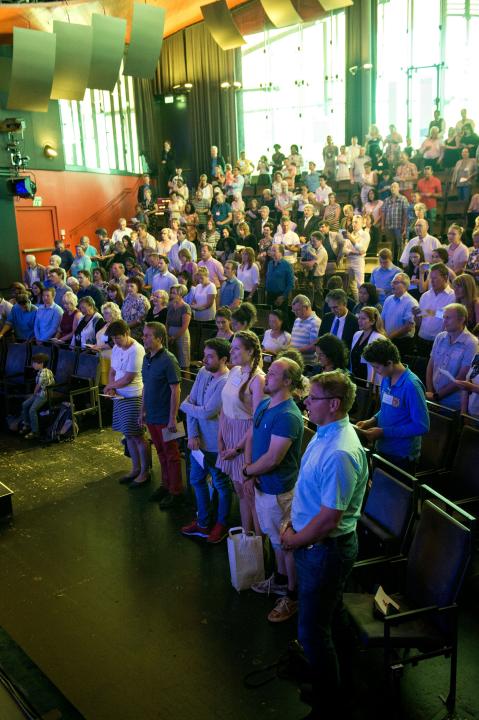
[{"xmin": 87, "ymin": 14, "xmax": 126, "ymax": 92}]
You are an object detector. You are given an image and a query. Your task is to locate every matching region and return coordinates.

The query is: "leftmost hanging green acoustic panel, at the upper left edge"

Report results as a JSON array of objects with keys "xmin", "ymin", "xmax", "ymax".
[{"xmin": 7, "ymin": 27, "xmax": 56, "ymax": 112}]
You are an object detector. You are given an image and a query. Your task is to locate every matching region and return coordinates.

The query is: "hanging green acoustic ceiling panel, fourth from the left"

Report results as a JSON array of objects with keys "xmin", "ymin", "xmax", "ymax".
[{"xmin": 123, "ymin": 3, "xmax": 166, "ymax": 78}]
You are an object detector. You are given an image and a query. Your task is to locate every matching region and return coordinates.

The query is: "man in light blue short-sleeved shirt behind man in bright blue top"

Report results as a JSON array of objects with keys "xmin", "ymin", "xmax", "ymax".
[{"xmin": 426, "ymin": 303, "xmax": 477, "ymax": 410}]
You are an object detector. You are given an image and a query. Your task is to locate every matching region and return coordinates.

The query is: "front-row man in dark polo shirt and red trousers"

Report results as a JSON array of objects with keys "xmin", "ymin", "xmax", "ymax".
[{"xmin": 141, "ymin": 322, "xmax": 183, "ymax": 510}]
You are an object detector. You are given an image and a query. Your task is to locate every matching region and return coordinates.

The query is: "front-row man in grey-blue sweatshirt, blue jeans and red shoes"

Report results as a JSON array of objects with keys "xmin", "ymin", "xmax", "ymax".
[{"xmin": 180, "ymin": 338, "xmax": 231, "ymax": 544}]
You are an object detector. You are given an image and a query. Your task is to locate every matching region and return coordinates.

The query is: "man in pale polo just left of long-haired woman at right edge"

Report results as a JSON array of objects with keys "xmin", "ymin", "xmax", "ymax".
[{"xmin": 413, "ymin": 263, "xmax": 455, "ymax": 357}]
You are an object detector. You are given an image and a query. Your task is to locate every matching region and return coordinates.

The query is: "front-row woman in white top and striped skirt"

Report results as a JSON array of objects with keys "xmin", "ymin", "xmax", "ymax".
[{"xmin": 105, "ymin": 320, "xmax": 150, "ymax": 488}]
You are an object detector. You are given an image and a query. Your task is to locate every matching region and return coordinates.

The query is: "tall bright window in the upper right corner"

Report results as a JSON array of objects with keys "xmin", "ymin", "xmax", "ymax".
[{"xmin": 376, "ymin": 0, "xmax": 479, "ymax": 146}]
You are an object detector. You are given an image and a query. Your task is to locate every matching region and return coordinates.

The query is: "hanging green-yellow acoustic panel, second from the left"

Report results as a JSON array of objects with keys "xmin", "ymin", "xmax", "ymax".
[{"xmin": 50, "ymin": 20, "xmax": 93, "ymax": 100}]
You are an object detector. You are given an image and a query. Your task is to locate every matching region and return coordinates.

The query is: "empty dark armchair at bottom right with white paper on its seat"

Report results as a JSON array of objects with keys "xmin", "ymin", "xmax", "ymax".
[{"xmin": 344, "ymin": 498, "xmax": 474, "ymax": 713}]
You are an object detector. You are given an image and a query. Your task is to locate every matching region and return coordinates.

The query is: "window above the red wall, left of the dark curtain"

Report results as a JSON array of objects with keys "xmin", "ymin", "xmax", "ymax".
[{"xmin": 59, "ymin": 69, "xmax": 142, "ymax": 174}]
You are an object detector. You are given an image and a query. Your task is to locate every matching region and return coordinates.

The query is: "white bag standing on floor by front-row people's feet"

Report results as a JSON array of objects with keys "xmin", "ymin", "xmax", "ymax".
[{"xmin": 227, "ymin": 527, "xmax": 264, "ymax": 592}]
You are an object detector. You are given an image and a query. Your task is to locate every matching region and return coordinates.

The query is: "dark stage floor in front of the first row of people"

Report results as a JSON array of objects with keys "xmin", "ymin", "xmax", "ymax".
[{"xmin": 0, "ymin": 430, "xmax": 479, "ymax": 720}]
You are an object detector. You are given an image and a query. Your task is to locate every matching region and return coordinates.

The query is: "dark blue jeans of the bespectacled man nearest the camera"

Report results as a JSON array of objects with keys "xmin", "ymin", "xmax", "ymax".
[{"xmin": 294, "ymin": 532, "xmax": 358, "ymax": 717}]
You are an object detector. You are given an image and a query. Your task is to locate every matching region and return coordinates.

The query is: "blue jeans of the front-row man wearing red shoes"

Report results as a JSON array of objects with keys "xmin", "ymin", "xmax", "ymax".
[{"xmin": 190, "ymin": 451, "xmax": 232, "ymax": 527}]
